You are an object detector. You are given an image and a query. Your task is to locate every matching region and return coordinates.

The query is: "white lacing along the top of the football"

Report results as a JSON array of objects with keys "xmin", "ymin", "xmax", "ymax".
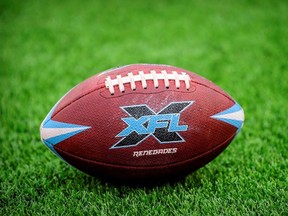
[{"xmin": 105, "ymin": 70, "xmax": 190, "ymax": 95}]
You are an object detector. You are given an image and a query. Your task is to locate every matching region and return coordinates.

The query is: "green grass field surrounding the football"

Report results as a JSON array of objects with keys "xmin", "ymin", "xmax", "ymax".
[{"xmin": 0, "ymin": 0, "xmax": 288, "ymax": 216}]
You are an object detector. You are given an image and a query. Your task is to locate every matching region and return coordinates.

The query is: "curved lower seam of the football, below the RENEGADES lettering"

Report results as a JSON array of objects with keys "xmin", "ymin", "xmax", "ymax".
[{"xmin": 55, "ymin": 134, "xmax": 237, "ymax": 170}]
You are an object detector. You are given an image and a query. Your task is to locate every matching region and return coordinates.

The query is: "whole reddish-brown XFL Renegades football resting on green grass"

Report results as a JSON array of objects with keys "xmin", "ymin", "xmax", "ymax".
[{"xmin": 40, "ymin": 64, "xmax": 244, "ymax": 182}]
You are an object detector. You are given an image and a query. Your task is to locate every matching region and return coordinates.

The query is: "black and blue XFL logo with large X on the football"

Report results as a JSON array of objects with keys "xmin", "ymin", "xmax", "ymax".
[{"xmin": 111, "ymin": 101, "xmax": 194, "ymax": 148}]
